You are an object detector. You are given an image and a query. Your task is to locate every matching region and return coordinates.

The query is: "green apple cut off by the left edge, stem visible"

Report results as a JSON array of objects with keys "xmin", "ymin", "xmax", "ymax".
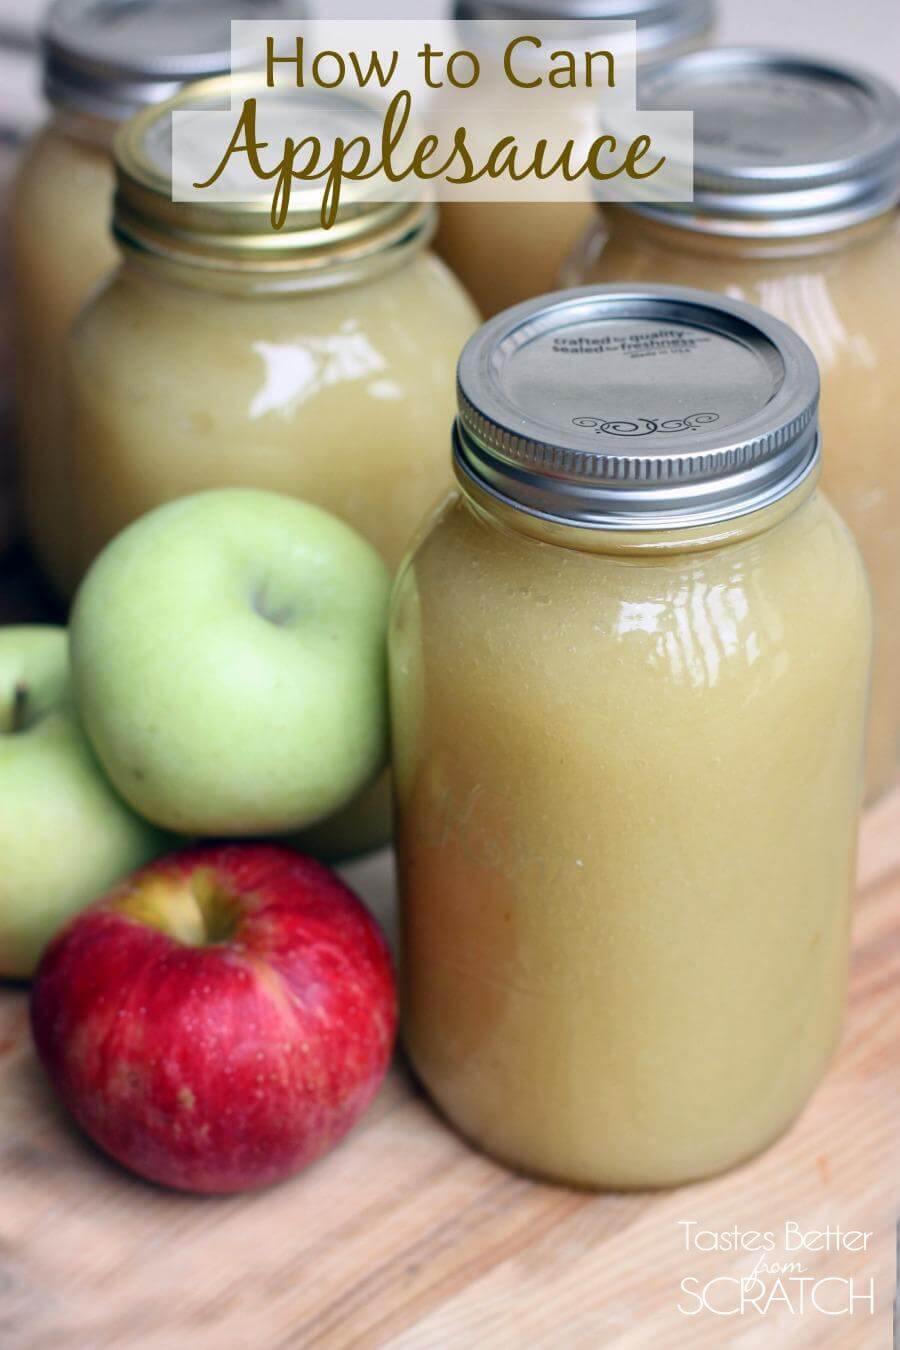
[{"xmin": 0, "ymin": 626, "xmax": 171, "ymax": 979}]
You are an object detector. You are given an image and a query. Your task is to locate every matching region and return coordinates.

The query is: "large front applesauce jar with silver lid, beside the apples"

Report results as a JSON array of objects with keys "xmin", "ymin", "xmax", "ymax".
[{"xmin": 390, "ymin": 286, "xmax": 870, "ymax": 1188}]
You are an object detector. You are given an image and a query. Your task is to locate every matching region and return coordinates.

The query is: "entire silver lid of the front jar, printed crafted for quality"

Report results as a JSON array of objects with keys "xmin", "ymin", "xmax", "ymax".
[{"xmin": 453, "ymin": 286, "xmax": 819, "ymax": 531}]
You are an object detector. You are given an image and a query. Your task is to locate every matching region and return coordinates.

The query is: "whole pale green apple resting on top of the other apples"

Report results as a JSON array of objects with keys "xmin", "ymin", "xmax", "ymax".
[{"xmin": 70, "ymin": 487, "xmax": 390, "ymax": 837}]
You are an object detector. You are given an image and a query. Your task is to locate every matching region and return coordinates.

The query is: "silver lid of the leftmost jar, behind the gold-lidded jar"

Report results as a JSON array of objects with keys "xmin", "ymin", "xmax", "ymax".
[{"xmin": 42, "ymin": 0, "xmax": 304, "ymax": 122}]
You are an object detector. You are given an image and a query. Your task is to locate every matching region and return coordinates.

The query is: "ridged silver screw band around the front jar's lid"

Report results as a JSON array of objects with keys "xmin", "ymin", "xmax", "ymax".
[{"xmin": 453, "ymin": 285, "xmax": 819, "ymax": 529}]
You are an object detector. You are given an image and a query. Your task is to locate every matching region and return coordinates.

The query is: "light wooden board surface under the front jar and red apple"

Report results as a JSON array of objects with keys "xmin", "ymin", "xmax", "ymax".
[{"xmin": 0, "ymin": 545, "xmax": 900, "ymax": 1350}]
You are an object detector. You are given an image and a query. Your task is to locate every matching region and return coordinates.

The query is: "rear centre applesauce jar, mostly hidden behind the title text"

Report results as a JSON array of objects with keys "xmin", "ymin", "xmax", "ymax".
[{"xmin": 434, "ymin": 0, "xmax": 714, "ymax": 319}]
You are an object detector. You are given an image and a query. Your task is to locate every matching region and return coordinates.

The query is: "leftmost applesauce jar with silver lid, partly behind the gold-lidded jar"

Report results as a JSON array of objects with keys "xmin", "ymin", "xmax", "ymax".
[{"xmin": 9, "ymin": 0, "xmax": 299, "ymax": 587}]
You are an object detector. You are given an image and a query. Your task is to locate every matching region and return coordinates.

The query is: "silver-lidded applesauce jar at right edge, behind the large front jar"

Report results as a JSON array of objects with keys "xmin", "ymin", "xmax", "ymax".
[{"xmin": 563, "ymin": 49, "xmax": 900, "ymax": 801}]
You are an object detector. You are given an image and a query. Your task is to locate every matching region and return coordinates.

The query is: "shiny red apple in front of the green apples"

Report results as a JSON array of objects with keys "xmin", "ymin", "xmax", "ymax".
[{"xmin": 31, "ymin": 844, "xmax": 397, "ymax": 1195}]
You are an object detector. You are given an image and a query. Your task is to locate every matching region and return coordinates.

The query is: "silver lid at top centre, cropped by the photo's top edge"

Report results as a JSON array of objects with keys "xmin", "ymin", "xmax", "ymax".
[{"xmin": 455, "ymin": 0, "xmax": 714, "ymax": 59}]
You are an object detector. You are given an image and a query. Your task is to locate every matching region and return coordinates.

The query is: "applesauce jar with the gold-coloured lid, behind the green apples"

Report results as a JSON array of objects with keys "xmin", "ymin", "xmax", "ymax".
[{"xmin": 66, "ymin": 80, "xmax": 478, "ymax": 855}]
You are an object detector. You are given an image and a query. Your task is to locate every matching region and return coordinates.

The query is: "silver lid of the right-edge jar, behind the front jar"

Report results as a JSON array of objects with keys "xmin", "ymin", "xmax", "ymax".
[{"xmin": 636, "ymin": 47, "xmax": 900, "ymax": 235}]
